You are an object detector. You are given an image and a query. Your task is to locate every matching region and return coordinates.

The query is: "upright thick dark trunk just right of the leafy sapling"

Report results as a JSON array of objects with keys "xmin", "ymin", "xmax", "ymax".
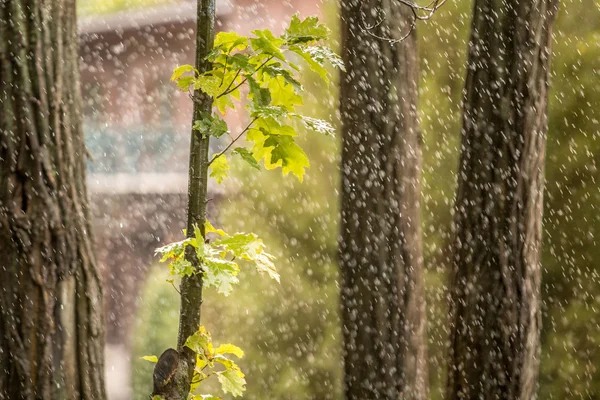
[{"xmin": 339, "ymin": 0, "xmax": 427, "ymax": 400}]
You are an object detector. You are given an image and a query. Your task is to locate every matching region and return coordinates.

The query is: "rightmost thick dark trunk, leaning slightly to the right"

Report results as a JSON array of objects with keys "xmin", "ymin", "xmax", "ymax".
[{"xmin": 447, "ymin": 0, "xmax": 557, "ymax": 400}]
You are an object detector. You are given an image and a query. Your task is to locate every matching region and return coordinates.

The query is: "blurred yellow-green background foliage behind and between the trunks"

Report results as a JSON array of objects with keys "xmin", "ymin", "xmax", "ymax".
[{"xmin": 133, "ymin": 0, "xmax": 600, "ymax": 399}]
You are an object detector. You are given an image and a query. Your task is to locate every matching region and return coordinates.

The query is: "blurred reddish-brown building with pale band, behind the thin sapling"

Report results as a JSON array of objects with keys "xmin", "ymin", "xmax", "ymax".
[{"xmin": 79, "ymin": 0, "xmax": 320, "ymax": 400}]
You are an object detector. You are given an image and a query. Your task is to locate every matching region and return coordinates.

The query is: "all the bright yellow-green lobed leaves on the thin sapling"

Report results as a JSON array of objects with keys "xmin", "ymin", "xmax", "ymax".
[{"xmin": 152, "ymin": 16, "xmax": 342, "ymax": 399}]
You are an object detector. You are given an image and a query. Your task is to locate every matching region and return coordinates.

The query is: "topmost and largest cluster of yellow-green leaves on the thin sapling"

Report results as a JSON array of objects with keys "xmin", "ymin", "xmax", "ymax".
[{"xmin": 171, "ymin": 15, "xmax": 343, "ymax": 183}]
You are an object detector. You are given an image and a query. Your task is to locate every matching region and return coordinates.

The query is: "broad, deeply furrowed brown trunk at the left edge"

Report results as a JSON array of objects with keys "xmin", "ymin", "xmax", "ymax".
[{"xmin": 0, "ymin": 0, "xmax": 105, "ymax": 400}]
